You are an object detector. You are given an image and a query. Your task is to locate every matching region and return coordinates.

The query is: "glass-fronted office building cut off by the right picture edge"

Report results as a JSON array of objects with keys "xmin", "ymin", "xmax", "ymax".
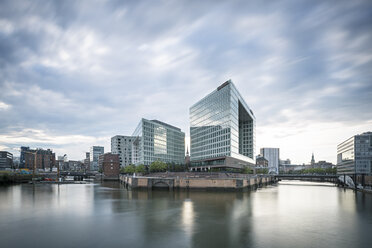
[{"xmin": 337, "ymin": 132, "xmax": 372, "ymax": 174}]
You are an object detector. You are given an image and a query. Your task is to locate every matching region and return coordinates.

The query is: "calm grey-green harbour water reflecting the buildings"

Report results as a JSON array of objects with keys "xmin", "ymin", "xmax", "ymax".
[{"xmin": 0, "ymin": 182, "xmax": 372, "ymax": 247}]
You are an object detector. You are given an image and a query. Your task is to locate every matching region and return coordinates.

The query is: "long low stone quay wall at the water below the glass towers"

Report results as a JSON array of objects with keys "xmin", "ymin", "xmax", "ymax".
[{"xmin": 120, "ymin": 175, "xmax": 276, "ymax": 190}]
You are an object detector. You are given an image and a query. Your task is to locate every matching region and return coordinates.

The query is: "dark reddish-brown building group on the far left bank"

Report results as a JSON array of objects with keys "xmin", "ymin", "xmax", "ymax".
[{"xmin": 21, "ymin": 147, "xmax": 56, "ymax": 171}]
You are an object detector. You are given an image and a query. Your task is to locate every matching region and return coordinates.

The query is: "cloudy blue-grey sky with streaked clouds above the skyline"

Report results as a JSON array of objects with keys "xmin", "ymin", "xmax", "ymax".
[{"xmin": 0, "ymin": 0, "xmax": 372, "ymax": 164}]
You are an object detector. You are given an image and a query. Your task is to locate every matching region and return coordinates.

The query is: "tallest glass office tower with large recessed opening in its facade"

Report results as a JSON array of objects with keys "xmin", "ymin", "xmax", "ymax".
[{"xmin": 190, "ymin": 80, "xmax": 256, "ymax": 171}]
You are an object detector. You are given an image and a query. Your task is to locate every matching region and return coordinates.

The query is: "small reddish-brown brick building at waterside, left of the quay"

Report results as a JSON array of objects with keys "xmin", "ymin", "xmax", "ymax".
[{"xmin": 99, "ymin": 153, "xmax": 120, "ymax": 179}]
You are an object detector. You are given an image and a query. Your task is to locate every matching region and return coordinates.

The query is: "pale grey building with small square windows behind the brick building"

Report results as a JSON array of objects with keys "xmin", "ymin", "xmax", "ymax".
[{"xmin": 111, "ymin": 135, "xmax": 134, "ymax": 167}]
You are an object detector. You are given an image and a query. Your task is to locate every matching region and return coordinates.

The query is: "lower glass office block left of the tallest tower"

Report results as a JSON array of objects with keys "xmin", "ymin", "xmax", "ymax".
[{"xmin": 132, "ymin": 119, "xmax": 185, "ymax": 165}]
